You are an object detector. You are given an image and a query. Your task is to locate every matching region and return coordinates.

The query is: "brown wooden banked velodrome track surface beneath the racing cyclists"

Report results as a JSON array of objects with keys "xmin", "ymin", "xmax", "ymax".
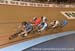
[{"xmin": 0, "ymin": 5, "xmax": 75, "ymax": 48}]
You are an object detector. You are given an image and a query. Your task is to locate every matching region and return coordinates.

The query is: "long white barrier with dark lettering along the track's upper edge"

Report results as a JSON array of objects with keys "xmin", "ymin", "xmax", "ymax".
[{"xmin": 0, "ymin": 0, "xmax": 75, "ymax": 8}]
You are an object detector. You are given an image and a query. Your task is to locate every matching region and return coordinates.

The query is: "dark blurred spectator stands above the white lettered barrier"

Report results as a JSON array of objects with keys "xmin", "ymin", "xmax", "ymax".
[{"xmin": 14, "ymin": 0, "xmax": 75, "ymax": 4}]
